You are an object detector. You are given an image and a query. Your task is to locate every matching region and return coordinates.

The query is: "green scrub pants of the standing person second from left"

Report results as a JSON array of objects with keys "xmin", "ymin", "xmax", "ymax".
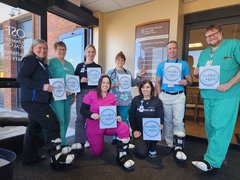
[{"xmin": 51, "ymin": 96, "xmax": 72, "ymax": 145}]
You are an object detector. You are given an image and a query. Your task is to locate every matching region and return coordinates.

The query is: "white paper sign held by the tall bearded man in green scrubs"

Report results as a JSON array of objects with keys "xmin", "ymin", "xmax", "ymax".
[{"xmin": 199, "ymin": 66, "xmax": 220, "ymax": 89}]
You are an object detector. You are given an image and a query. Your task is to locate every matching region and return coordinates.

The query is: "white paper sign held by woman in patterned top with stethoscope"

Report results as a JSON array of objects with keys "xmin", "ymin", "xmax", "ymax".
[{"xmin": 118, "ymin": 74, "xmax": 132, "ymax": 92}]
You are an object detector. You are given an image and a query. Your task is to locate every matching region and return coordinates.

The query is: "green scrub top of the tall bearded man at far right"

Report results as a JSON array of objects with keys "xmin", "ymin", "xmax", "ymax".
[{"xmin": 198, "ymin": 39, "xmax": 240, "ymax": 99}]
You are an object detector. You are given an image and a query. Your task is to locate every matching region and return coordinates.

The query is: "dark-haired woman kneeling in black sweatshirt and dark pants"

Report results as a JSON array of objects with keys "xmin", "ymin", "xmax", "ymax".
[{"xmin": 129, "ymin": 80, "xmax": 164, "ymax": 158}]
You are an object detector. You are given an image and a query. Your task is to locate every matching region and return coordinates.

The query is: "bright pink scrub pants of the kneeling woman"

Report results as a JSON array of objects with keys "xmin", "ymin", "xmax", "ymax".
[{"xmin": 86, "ymin": 119, "xmax": 129, "ymax": 156}]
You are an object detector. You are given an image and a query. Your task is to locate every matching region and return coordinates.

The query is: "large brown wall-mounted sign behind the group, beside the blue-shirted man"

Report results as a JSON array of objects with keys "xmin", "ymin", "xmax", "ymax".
[{"xmin": 135, "ymin": 21, "xmax": 169, "ymax": 80}]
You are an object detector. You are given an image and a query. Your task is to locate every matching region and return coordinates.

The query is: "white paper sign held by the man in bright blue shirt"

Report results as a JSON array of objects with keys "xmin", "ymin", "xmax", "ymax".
[{"xmin": 163, "ymin": 63, "xmax": 182, "ymax": 84}]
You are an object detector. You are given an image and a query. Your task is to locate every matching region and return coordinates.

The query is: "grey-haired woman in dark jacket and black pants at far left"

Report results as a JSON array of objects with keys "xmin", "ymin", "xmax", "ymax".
[{"xmin": 17, "ymin": 39, "xmax": 74, "ymax": 169}]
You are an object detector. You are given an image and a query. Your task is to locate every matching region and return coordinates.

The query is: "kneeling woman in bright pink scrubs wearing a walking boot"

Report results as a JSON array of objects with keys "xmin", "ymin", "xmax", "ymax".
[{"xmin": 81, "ymin": 75, "xmax": 134, "ymax": 171}]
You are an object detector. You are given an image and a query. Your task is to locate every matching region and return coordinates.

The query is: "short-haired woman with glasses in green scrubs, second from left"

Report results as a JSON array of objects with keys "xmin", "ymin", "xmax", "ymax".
[{"xmin": 49, "ymin": 41, "xmax": 75, "ymax": 146}]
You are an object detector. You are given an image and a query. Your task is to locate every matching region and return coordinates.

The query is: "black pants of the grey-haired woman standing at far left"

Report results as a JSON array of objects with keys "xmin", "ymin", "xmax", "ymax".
[{"xmin": 21, "ymin": 102, "xmax": 60, "ymax": 163}]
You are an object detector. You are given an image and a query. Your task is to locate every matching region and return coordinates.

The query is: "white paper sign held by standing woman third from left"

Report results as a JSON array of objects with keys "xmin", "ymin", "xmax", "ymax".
[{"xmin": 87, "ymin": 67, "xmax": 101, "ymax": 86}]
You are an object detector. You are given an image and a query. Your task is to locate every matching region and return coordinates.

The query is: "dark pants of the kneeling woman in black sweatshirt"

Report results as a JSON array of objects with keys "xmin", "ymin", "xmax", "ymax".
[{"xmin": 133, "ymin": 134, "xmax": 157, "ymax": 158}]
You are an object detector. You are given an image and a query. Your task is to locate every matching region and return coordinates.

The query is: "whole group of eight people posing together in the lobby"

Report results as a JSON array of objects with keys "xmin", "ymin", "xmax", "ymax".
[{"xmin": 17, "ymin": 25, "xmax": 240, "ymax": 172}]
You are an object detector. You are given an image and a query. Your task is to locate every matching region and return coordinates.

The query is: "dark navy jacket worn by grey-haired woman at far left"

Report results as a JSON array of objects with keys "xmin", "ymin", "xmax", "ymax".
[{"xmin": 17, "ymin": 55, "xmax": 52, "ymax": 103}]
